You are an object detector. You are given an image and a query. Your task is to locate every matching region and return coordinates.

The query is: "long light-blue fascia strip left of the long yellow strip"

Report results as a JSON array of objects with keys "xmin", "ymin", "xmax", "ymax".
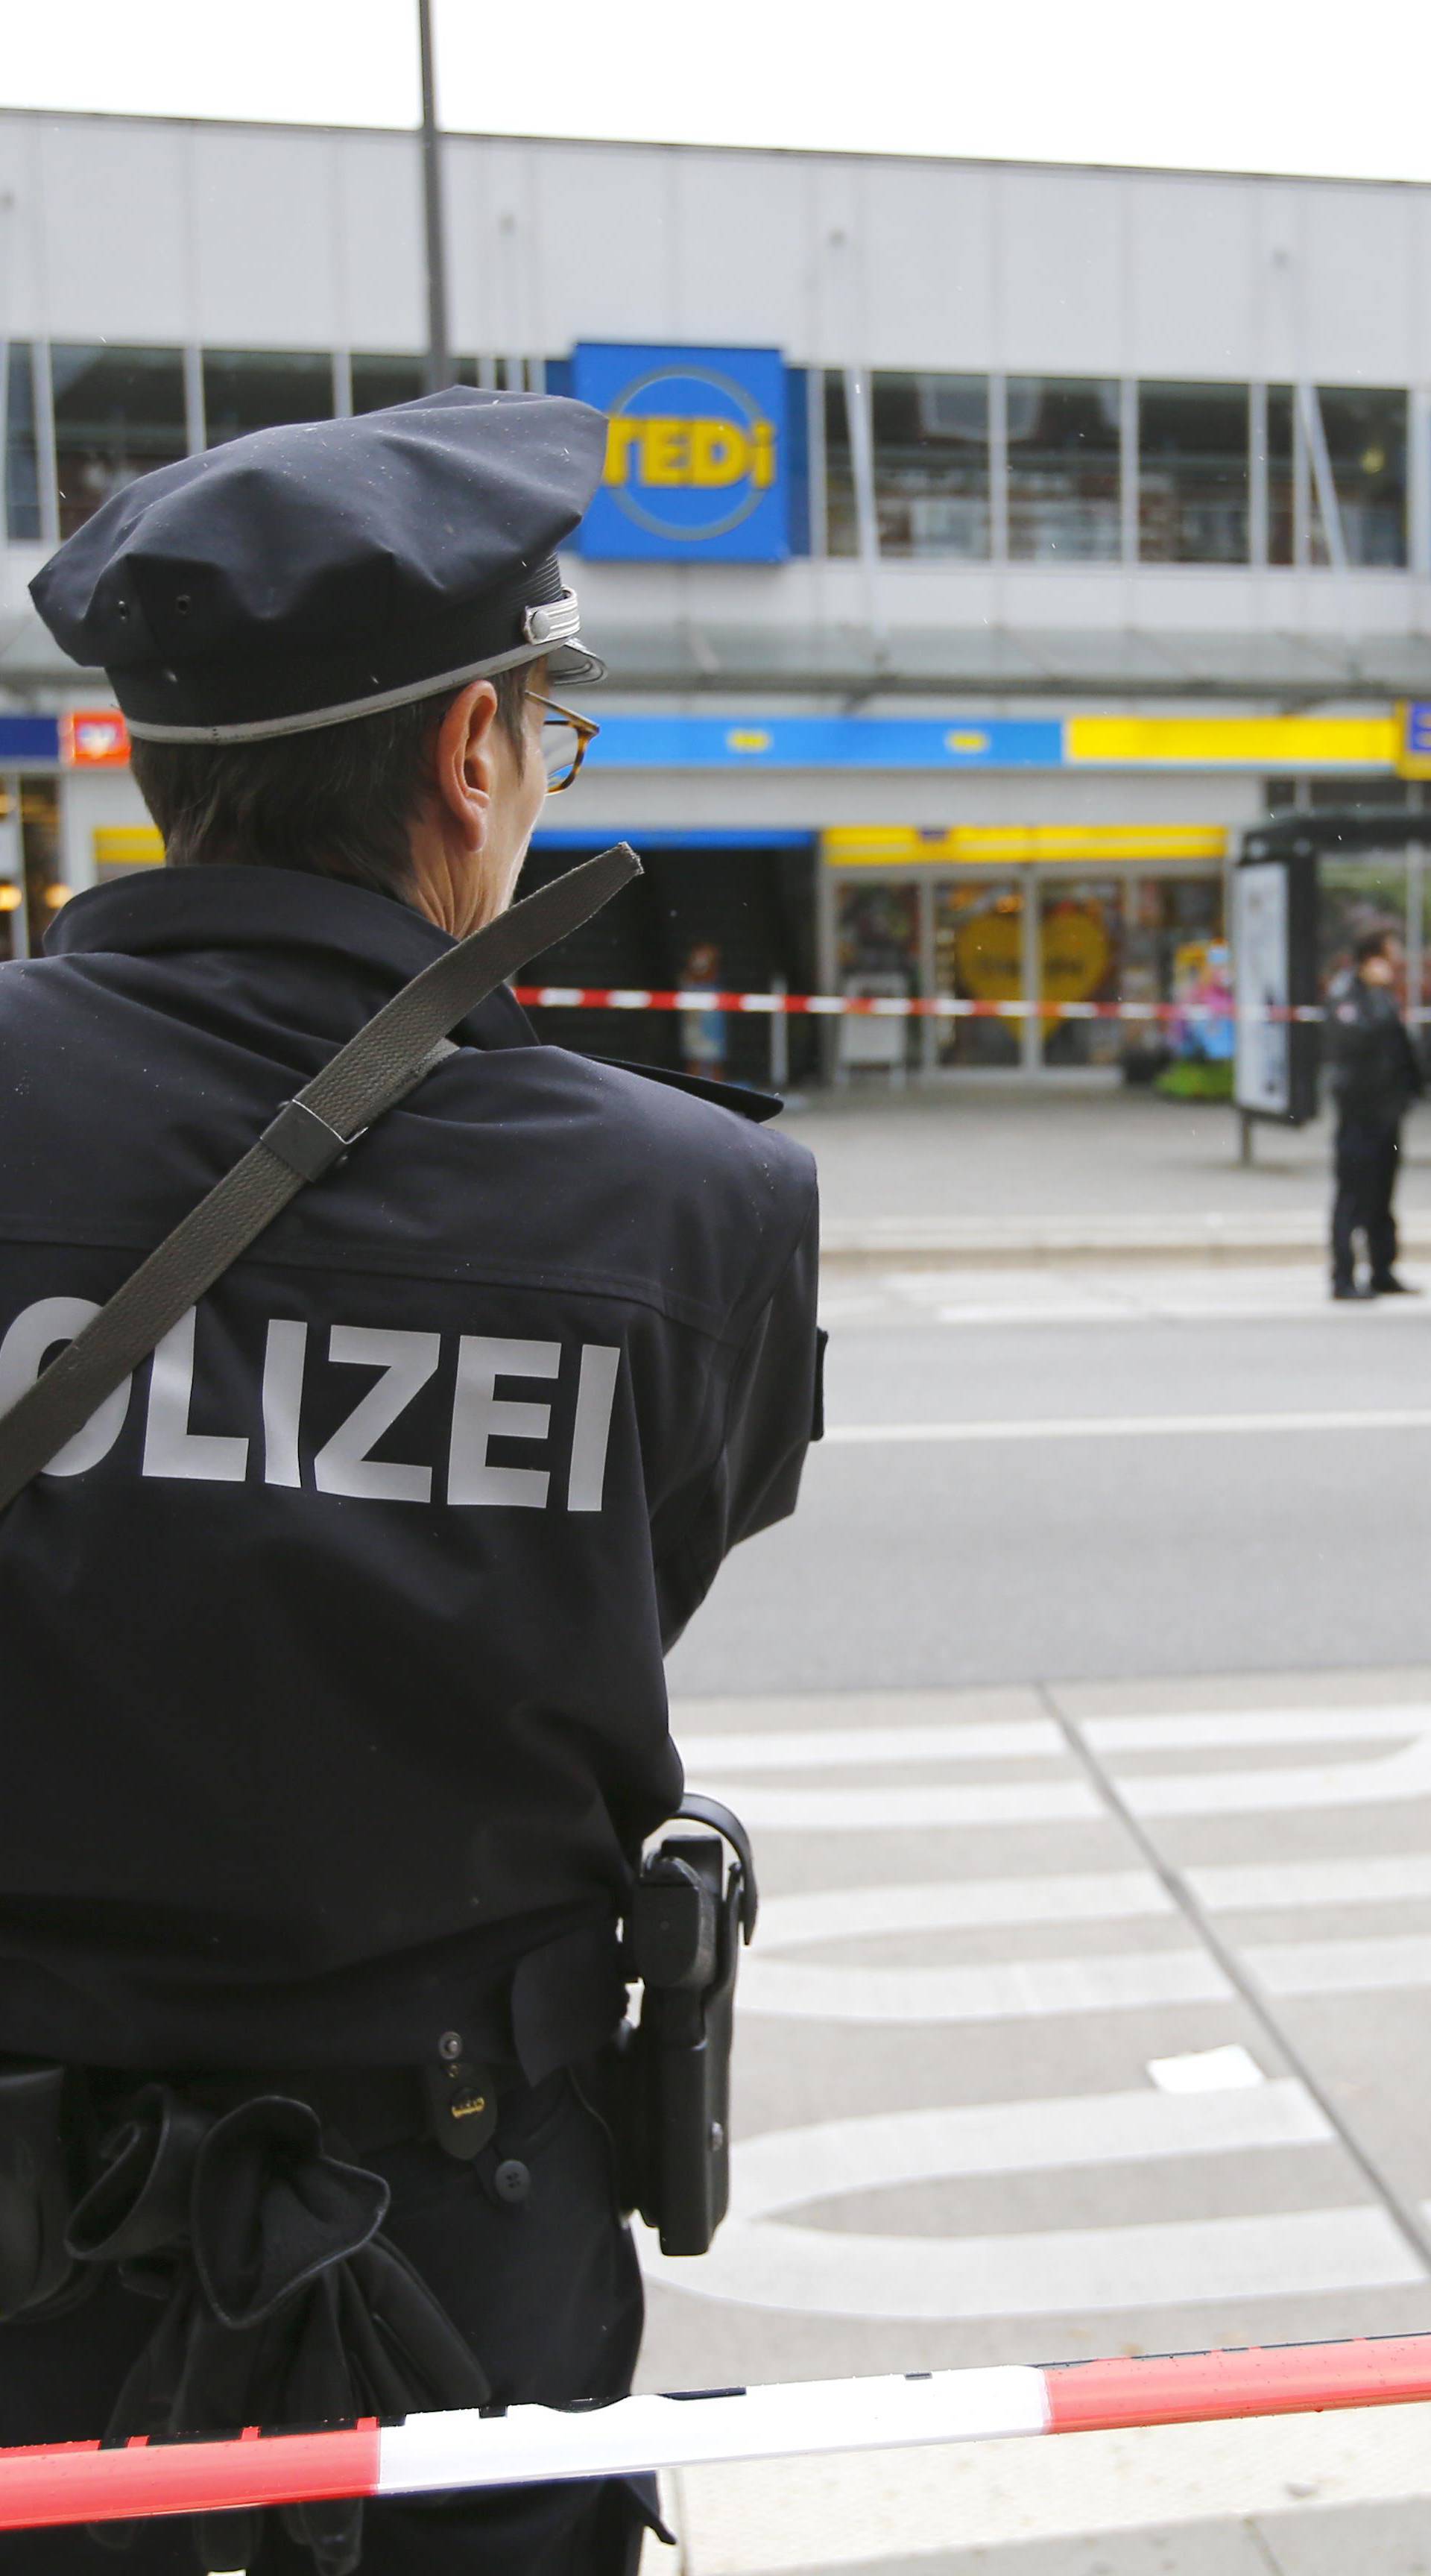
[{"xmin": 587, "ymin": 716, "xmax": 1063, "ymax": 770}]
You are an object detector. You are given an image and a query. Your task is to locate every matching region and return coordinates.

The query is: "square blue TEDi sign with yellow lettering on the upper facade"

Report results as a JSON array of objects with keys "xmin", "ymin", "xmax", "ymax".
[{"xmin": 572, "ymin": 340, "xmax": 790, "ymax": 564}]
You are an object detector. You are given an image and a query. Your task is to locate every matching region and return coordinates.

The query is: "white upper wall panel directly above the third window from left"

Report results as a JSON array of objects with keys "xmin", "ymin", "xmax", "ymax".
[{"xmin": 191, "ymin": 126, "xmax": 342, "ymax": 348}]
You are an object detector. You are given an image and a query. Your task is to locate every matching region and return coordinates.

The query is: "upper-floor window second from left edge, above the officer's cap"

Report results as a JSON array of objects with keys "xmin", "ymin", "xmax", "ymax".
[{"xmin": 49, "ymin": 343, "xmax": 188, "ymax": 536}]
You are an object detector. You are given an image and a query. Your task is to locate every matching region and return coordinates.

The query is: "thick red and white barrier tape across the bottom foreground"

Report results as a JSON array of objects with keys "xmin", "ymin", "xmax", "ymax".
[{"xmin": 0, "ymin": 2334, "xmax": 1431, "ymax": 2532}]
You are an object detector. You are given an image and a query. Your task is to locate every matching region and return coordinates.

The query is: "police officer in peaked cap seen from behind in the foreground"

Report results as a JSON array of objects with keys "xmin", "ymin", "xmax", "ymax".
[{"xmin": 0, "ymin": 389, "xmax": 818, "ymax": 2576}]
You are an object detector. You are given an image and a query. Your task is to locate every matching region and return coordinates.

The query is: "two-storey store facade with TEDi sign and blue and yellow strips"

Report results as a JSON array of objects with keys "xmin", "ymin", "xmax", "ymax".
[{"xmin": 0, "ymin": 113, "xmax": 1431, "ymax": 1082}]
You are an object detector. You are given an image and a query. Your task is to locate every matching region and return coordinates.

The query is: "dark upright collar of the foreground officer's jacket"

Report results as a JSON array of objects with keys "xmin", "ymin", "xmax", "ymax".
[{"xmin": 44, "ymin": 868, "xmax": 538, "ymax": 1046}]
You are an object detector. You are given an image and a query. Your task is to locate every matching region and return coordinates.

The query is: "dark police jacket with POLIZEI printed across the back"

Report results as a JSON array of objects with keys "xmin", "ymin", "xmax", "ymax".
[{"xmin": 0, "ymin": 868, "xmax": 816, "ymax": 2068}]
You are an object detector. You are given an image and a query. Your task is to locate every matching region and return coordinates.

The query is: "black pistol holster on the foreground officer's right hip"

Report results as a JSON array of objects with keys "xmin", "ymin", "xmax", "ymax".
[{"xmin": 620, "ymin": 1796, "xmax": 756, "ymax": 2254}]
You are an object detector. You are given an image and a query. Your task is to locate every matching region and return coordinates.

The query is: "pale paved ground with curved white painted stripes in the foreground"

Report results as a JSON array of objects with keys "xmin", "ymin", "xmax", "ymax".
[{"xmin": 641, "ymin": 1661, "xmax": 1431, "ymax": 2576}]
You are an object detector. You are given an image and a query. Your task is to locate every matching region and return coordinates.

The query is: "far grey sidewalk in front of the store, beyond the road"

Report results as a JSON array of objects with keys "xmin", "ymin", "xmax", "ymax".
[{"xmin": 785, "ymin": 1085, "xmax": 1431, "ymax": 1262}]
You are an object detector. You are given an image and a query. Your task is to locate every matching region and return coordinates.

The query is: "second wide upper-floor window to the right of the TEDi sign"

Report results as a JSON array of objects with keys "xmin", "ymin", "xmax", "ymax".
[{"xmin": 1009, "ymin": 376, "xmax": 1119, "ymax": 564}]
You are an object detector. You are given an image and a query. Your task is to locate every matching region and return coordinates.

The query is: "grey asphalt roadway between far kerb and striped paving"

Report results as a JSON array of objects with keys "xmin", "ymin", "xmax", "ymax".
[{"xmin": 672, "ymin": 1265, "xmax": 1431, "ymax": 1693}]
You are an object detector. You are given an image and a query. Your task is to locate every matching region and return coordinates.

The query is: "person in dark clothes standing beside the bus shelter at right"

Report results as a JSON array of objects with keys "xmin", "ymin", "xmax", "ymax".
[{"xmin": 1325, "ymin": 930, "xmax": 1426, "ymax": 1298}]
